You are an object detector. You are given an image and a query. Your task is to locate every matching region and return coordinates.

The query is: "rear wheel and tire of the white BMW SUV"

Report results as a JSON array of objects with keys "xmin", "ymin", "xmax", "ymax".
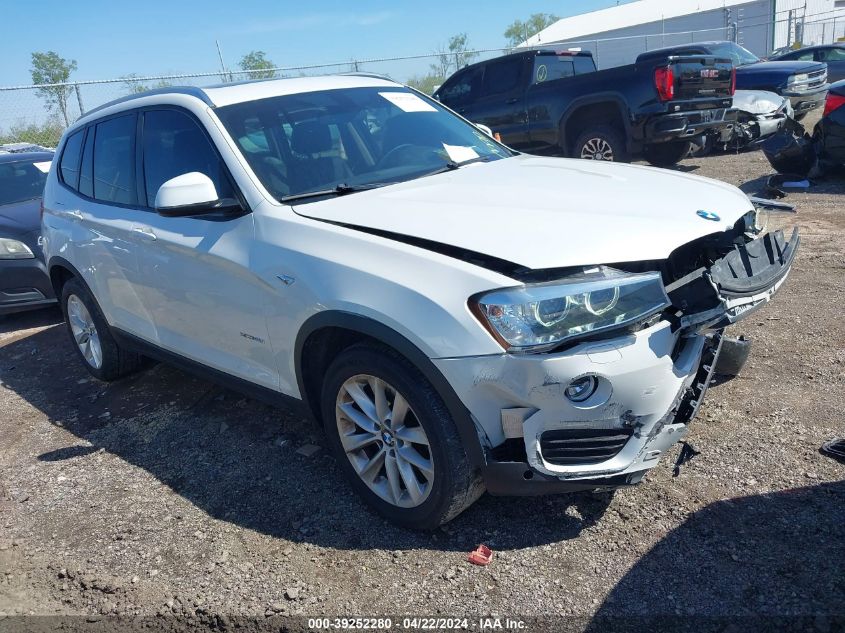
[{"xmin": 60, "ymin": 278, "xmax": 141, "ymax": 381}]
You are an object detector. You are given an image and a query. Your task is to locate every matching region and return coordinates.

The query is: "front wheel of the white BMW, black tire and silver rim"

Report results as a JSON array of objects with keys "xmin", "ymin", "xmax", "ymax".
[{"xmin": 322, "ymin": 345, "xmax": 484, "ymax": 530}]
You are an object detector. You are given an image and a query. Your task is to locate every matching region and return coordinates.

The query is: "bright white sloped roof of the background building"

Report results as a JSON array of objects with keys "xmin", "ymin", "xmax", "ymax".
[{"xmin": 520, "ymin": 0, "xmax": 749, "ymax": 46}]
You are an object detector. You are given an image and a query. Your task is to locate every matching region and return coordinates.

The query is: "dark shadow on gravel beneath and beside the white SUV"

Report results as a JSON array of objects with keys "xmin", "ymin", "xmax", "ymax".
[{"xmin": 0, "ymin": 325, "xmax": 611, "ymax": 551}]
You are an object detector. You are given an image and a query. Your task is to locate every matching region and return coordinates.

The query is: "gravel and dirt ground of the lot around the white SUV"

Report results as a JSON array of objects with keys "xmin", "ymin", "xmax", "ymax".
[{"xmin": 0, "ymin": 115, "xmax": 845, "ymax": 630}]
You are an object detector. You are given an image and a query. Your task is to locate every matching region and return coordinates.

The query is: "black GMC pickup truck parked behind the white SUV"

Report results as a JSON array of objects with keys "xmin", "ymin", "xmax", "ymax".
[{"xmin": 434, "ymin": 50, "xmax": 736, "ymax": 166}]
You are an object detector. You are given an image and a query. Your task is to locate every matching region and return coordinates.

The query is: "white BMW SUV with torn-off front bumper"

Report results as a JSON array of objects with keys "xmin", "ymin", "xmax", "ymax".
[{"xmin": 43, "ymin": 75, "xmax": 798, "ymax": 528}]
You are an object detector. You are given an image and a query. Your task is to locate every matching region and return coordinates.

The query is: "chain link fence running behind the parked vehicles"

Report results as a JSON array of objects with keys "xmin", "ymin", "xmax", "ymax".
[{"xmin": 0, "ymin": 11, "xmax": 845, "ymax": 147}]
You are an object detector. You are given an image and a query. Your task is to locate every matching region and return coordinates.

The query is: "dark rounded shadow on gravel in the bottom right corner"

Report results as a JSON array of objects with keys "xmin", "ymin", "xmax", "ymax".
[{"xmin": 588, "ymin": 481, "xmax": 845, "ymax": 631}]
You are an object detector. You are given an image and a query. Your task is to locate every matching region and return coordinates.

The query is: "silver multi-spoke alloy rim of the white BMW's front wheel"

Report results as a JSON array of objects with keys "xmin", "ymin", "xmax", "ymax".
[{"xmin": 335, "ymin": 374, "xmax": 435, "ymax": 508}]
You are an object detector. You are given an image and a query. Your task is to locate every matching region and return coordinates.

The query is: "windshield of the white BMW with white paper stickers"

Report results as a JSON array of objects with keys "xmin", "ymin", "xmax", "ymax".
[{"xmin": 217, "ymin": 87, "xmax": 512, "ymax": 200}]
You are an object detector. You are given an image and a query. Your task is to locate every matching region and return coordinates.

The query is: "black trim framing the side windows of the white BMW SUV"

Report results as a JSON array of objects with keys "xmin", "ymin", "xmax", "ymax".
[{"xmin": 57, "ymin": 103, "xmax": 247, "ymax": 221}]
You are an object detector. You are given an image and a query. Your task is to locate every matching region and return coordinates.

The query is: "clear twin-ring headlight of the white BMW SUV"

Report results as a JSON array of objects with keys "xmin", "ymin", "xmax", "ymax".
[{"xmin": 470, "ymin": 266, "xmax": 669, "ymax": 352}]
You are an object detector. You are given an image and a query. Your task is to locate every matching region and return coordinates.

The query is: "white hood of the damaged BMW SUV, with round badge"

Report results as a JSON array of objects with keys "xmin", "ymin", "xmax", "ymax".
[{"xmin": 295, "ymin": 155, "xmax": 753, "ymax": 269}]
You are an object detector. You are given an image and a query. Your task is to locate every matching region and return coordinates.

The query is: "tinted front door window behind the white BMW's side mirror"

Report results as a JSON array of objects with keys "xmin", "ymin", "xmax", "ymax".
[{"xmin": 143, "ymin": 110, "xmax": 234, "ymax": 207}]
